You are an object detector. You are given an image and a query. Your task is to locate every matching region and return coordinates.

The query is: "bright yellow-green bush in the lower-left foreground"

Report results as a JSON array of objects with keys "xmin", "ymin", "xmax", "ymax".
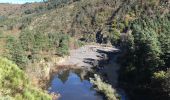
[{"xmin": 0, "ymin": 58, "xmax": 51, "ymax": 100}]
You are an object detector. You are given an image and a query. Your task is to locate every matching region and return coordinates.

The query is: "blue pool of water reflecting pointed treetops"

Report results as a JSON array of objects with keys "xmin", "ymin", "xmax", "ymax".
[{"xmin": 49, "ymin": 71, "xmax": 104, "ymax": 100}]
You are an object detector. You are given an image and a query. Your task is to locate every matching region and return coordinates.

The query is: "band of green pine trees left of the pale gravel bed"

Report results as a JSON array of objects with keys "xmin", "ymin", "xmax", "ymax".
[{"xmin": 6, "ymin": 30, "xmax": 70, "ymax": 66}]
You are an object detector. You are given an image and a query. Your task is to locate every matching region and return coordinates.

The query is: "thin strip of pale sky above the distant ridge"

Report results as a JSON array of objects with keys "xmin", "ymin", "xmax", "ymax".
[{"xmin": 0, "ymin": 0, "xmax": 43, "ymax": 4}]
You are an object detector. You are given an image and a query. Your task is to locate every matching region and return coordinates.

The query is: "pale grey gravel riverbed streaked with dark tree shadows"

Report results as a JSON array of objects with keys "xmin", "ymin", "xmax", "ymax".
[{"xmin": 58, "ymin": 45, "xmax": 118, "ymax": 69}]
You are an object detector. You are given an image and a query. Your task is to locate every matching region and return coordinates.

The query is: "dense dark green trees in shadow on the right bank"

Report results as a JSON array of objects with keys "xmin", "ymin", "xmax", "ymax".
[{"xmin": 121, "ymin": 15, "xmax": 170, "ymax": 99}]
